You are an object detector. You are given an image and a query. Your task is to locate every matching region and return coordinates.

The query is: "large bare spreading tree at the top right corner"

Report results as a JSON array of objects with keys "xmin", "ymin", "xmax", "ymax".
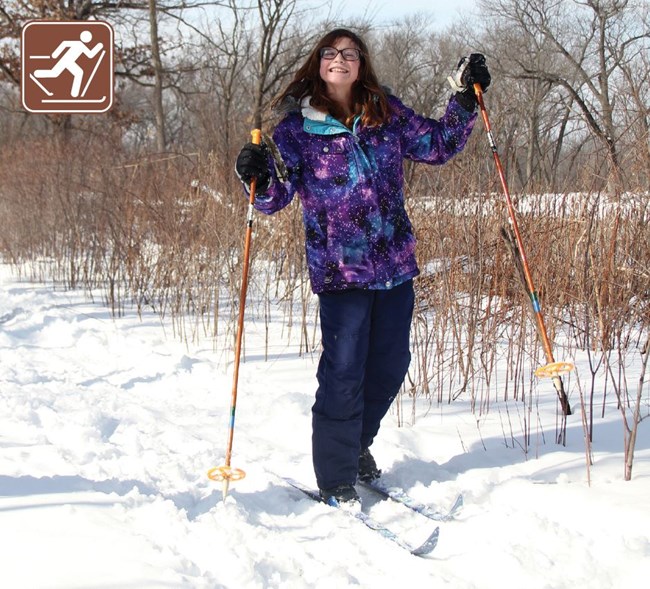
[{"xmin": 481, "ymin": 0, "xmax": 650, "ymax": 191}]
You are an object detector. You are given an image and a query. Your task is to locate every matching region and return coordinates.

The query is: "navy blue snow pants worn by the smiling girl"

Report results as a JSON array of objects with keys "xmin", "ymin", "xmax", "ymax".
[{"xmin": 312, "ymin": 280, "xmax": 414, "ymax": 489}]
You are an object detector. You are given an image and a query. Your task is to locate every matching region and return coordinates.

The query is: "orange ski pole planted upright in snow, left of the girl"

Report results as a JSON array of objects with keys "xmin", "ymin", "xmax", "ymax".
[{"xmin": 208, "ymin": 129, "xmax": 262, "ymax": 501}]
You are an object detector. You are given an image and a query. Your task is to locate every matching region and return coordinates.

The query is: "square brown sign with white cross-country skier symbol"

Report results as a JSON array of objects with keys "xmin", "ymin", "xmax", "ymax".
[{"xmin": 21, "ymin": 21, "xmax": 113, "ymax": 113}]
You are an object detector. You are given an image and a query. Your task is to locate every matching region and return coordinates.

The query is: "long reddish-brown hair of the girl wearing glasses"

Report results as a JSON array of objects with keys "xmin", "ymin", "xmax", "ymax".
[{"xmin": 273, "ymin": 29, "xmax": 390, "ymax": 126}]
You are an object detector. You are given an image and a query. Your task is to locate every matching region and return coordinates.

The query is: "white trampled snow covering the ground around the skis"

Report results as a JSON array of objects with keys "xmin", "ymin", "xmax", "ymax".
[{"xmin": 0, "ymin": 265, "xmax": 650, "ymax": 589}]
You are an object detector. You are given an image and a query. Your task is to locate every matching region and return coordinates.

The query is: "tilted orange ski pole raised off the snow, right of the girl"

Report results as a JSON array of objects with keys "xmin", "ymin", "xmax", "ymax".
[{"xmin": 474, "ymin": 83, "xmax": 574, "ymax": 415}]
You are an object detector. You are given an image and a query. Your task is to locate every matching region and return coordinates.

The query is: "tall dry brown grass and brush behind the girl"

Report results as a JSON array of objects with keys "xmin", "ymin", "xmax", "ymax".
[{"xmin": 0, "ymin": 139, "xmax": 650, "ymax": 450}]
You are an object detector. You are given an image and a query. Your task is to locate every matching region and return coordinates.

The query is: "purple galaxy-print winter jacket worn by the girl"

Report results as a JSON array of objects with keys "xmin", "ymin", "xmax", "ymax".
[{"xmin": 255, "ymin": 96, "xmax": 476, "ymax": 293}]
